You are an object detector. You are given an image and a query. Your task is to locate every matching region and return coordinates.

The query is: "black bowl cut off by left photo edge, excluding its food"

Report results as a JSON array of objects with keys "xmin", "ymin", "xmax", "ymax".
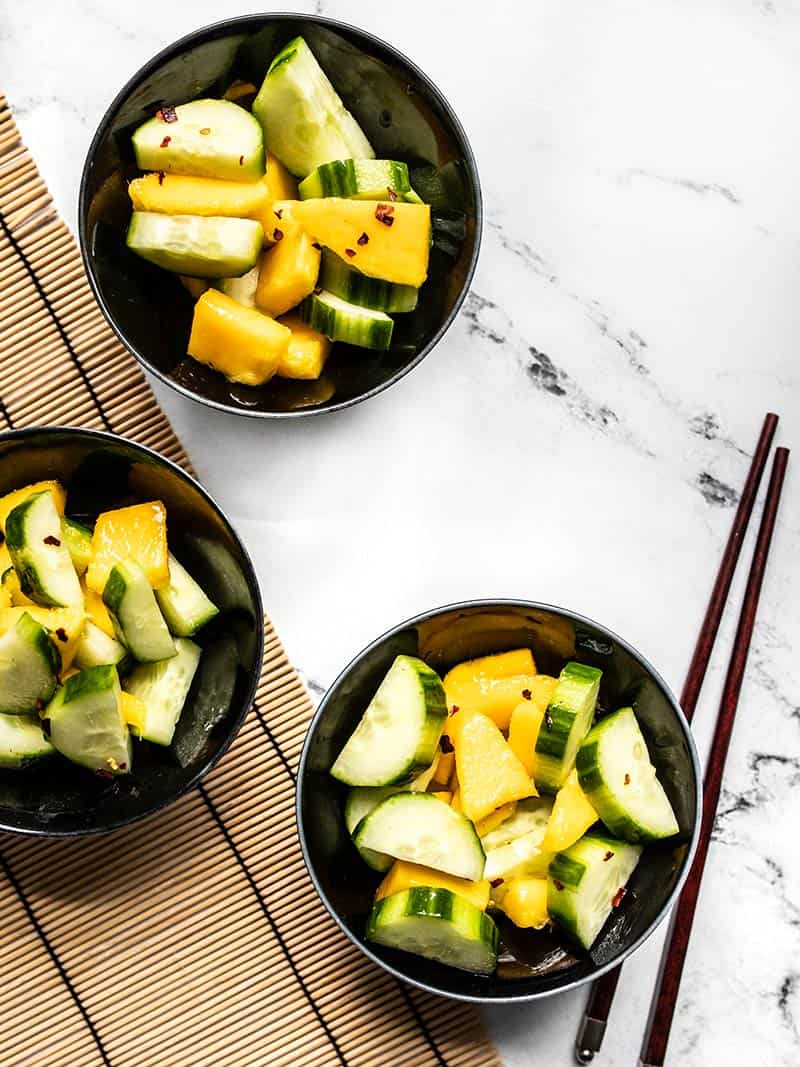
[{"xmin": 0, "ymin": 427, "xmax": 263, "ymax": 837}]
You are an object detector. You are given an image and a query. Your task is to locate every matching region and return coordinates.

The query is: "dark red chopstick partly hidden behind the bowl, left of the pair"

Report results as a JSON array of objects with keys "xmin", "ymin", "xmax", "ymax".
[{"xmin": 575, "ymin": 412, "xmax": 778, "ymax": 1064}]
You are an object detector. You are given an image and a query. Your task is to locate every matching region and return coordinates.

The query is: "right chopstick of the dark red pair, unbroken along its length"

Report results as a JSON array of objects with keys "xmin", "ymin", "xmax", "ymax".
[{"xmin": 640, "ymin": 448, "xmax": 789, "ymax": 1067}]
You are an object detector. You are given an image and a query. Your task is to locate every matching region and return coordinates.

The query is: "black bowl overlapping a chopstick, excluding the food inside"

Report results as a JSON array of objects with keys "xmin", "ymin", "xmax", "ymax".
[{"xmin": 298, "ymin": 601, "xmax": 700, "ymax": 1003}]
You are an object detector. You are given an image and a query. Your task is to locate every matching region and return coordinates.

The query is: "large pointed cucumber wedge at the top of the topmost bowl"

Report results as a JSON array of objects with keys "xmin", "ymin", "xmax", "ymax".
[{"xmin": 253, "ymin": 37, "xmax": 374, "ymax": 178}]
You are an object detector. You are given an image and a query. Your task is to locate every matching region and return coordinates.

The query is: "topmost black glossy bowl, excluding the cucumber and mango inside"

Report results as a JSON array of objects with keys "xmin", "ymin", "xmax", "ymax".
[{"xmin": 78, "ymin": 14, "xmax": 481, "ymax": 417}]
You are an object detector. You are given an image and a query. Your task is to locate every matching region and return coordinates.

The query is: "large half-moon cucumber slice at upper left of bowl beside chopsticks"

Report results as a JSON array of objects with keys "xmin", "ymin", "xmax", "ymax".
[{"xmin": 331, "ymin": 656, "xmax": 447, "ymax": 785}]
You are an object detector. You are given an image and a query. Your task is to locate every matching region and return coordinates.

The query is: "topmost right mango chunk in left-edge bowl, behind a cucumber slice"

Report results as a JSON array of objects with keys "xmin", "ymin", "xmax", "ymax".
[{"xmin": 86, "ymin": 500, "xmax": 170, "ymax": 594}]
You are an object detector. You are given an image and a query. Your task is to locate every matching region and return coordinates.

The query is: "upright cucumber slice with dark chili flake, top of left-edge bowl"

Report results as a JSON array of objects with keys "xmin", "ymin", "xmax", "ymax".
[{"xmin": 5, "ymin": 490, "xmax": 83, "ymax": 607}]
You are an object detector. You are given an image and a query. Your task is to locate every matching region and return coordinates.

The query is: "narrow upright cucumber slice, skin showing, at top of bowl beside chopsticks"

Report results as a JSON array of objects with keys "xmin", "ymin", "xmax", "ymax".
[{"xmin": 533, "ymin": 663, "xmax": 603, "ymax": 793}]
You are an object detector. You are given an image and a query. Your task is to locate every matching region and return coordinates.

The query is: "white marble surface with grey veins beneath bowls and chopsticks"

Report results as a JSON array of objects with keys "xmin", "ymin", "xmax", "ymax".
[{"xmin": 0, "ymin": 0, "xmax": 800, "ymax": 1067}]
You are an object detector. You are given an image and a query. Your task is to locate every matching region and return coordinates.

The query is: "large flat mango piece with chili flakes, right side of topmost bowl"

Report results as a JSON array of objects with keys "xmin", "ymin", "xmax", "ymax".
[{"xmin": 292, "ymin": 196, "xmax": 431, "ymax": 288}]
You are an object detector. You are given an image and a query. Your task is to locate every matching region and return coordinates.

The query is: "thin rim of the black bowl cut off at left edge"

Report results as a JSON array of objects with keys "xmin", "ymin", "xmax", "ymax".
[{"xmin": 0, "ymin": 424, "xmax": 265, "ymax": 838}]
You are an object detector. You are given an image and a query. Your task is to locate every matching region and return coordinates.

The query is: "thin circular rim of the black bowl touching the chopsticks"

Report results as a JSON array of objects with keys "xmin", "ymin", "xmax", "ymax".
[{"xmin": 294, "ymin": 598, "xmax": 703, "ymax": 1006}]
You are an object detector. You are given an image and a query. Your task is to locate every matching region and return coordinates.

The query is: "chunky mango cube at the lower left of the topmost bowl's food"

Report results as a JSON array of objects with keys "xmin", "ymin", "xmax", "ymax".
[{"xmin": 188, "ymin": 289, "xmax": 291, "ymax": 385}]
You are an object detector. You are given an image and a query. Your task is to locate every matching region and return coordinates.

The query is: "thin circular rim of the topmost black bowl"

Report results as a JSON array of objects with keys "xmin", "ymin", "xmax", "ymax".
[{"xmin": 78, "ymin": 11, "xmax": 483, "ymax": 419}]
